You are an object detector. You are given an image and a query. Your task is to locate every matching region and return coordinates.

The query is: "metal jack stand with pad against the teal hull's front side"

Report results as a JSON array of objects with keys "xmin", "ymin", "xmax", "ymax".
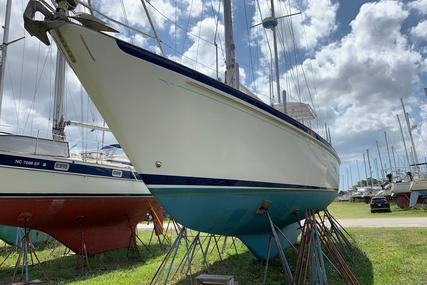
[{"xmin": 257, "ymin": 200, "xmax": 295, "ymax": 285}]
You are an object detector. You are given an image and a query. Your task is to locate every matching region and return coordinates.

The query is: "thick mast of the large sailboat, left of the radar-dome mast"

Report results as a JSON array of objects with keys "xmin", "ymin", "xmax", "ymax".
[{"xmin": 224, "ymin": 0, "xmax": 240, "ymax": 89}]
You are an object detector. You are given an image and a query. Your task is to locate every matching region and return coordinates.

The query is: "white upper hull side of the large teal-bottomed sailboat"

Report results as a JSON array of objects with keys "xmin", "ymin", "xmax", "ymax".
[{"xmin": 52, "ymin": 24, "xmax": 339, "ymax": 189}]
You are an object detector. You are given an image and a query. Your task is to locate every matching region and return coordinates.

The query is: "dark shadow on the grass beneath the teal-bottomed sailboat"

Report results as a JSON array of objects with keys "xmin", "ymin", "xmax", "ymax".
[{"xmin": 175, "ymin": 242, "xmax": 374, "ymax": 285}]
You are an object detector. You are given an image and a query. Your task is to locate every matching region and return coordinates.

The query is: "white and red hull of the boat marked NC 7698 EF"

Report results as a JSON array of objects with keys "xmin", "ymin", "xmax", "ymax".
[{"xmin": 0, "ymin": 152, "xmax": 163, "ymax": 254}]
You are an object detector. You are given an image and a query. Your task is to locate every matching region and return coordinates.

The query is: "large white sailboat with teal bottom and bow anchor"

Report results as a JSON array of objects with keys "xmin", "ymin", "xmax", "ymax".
[{"xmin": 24, "ymin": 0, "xmax": 340, "ymax": 259}]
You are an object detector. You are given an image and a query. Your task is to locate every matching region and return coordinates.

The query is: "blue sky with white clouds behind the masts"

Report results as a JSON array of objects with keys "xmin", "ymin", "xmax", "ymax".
[{"xmin": 0, "ymin": 0, "xmax": 427, "ymax": 189}]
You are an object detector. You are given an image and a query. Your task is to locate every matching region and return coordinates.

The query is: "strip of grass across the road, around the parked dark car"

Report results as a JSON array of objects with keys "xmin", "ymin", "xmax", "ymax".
[{"xmin": 328, "ymin": 202, "xmax": 427, "ymax": 219}]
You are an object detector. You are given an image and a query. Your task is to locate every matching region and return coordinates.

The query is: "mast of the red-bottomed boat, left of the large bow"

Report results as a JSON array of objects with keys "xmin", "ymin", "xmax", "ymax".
[{"xmin": 52, "ymin": 49, "xmax": 65, "ymax": 141}]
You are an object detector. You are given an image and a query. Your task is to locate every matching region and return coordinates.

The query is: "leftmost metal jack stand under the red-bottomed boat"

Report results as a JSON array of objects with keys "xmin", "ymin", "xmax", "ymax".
[{"xmin": 10, "ymin": 215, "xmax": 49, "ymax": 284}]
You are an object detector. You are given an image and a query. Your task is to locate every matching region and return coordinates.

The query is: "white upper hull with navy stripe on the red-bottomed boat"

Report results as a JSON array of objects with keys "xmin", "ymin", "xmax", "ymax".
[{"xmin": 0, "ymin": 152, "xmax": 151, "ymax": 197}]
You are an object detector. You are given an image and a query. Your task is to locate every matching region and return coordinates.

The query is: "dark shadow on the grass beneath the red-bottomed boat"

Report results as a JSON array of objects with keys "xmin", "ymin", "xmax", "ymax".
[{"xmin": 0, "ymin": 240, "xmax": 166, "ymax": 284}]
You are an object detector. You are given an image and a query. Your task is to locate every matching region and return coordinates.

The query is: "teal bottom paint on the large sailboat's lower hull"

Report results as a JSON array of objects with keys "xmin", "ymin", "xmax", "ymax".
[{"xmin": 149, "ymin": 187, "xmax": 336, "ymax": 259}]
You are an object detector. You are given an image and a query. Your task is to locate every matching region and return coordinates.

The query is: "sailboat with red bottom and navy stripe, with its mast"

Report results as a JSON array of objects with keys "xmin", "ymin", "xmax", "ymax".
[{"xmin": 0, "ymin": 0, "xmax": 163, "ymax": 255}]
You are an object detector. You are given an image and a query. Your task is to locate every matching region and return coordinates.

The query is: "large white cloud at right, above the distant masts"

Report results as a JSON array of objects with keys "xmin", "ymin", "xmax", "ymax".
[{"xmin": 284, "ymin": 1, "xmax": 424, "ymax": 164}]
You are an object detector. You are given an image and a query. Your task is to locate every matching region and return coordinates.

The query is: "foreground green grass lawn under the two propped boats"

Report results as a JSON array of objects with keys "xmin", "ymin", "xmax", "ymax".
[{"xmin": 0, "ymin": 228, "xmax": 427, "ymax": 285}]
